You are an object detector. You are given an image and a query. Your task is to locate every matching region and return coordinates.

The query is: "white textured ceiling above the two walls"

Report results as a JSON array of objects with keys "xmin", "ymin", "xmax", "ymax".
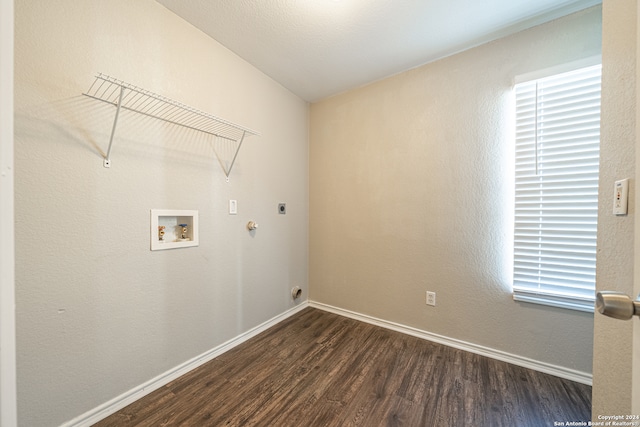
[{"xmin": 157, "ymin": 0, "xmax": 601, "ymax": 102}]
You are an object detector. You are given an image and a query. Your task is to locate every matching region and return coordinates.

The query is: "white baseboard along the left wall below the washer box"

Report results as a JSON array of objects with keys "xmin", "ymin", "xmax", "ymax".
[{"xmin": 61, "ymin": 301, "xmax": 308, "ymax": 427}]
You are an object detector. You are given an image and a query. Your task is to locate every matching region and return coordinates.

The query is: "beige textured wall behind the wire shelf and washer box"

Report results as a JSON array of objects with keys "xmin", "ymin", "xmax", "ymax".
[{"xmin": 15, "ymin": 0, "xmax": 308, "ymax": 427}]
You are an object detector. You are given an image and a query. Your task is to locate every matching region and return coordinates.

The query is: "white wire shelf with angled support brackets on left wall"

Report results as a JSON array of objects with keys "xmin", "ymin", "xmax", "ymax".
[{"xmin": 83, "ymin": 73, "xmax": 259, "ymax": 179}]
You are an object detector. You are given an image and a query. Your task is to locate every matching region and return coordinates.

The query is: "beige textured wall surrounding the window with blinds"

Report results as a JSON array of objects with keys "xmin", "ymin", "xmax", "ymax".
[{"xmin": 309, "ymin": 7, "xmax": 601, "ymax": 372}]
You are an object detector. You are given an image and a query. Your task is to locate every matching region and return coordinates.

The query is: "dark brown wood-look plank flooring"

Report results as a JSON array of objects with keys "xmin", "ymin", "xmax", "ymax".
[{"xmin": 95, "ymin": 308, "xmax": 591, "ymax": 427}]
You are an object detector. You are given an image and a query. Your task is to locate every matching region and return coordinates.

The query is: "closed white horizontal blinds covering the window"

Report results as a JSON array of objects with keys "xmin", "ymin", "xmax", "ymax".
[{"xmin": 513, "ymin": 65, "xmax": 601, "ymax": 311}]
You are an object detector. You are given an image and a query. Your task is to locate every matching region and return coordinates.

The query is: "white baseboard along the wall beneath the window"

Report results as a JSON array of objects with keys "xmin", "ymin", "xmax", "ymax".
[{"xmin": 309, "ymin": 301, "xmax": 593, "ymax": 385}]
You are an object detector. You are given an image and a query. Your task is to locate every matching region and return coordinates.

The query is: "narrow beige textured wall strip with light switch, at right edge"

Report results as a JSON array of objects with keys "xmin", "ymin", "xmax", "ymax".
[{"xmin": 593, "ymin": 0, "xmax": 638, "ymax": 421}]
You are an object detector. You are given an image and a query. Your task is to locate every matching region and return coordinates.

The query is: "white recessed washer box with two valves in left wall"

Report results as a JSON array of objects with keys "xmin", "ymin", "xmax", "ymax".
[{"xmin": 150, "ymin": 209, "xmax": 199, "ymax": 251}]
